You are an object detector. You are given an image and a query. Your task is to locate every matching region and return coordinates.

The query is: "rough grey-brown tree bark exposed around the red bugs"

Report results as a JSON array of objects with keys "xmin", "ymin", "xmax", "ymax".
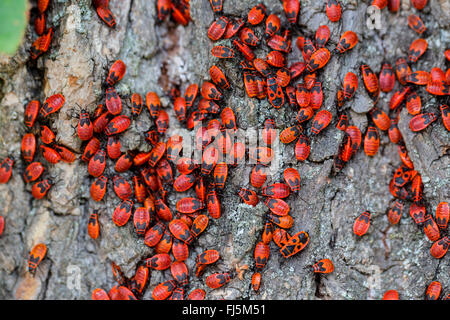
[{"xmin": 0, "ymin": 0, "xmax": 450, "ymax": 299}]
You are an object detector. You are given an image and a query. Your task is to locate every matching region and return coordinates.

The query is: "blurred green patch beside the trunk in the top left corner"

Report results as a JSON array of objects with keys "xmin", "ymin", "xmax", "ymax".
[{"xmin": 0, "ymin": 0, "xmax": 28, "ymax": 55}]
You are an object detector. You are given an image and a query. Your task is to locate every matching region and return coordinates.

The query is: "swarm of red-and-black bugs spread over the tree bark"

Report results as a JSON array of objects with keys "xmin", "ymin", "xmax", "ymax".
[{"xmin": 0, "ymin": 0, "xmax": 450, "ymax": 300}]
